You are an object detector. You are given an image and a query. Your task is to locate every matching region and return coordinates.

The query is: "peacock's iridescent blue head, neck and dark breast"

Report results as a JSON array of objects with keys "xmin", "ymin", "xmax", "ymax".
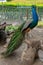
[{"xmin": 24, "ymin": 6, "xmax": 38, "ymax": 31}]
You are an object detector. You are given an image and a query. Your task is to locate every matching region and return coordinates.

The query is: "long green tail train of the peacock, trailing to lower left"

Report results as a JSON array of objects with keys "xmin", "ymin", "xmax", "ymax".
[{"xmin": 4, "ymin": 22, "xmax": 25, "ymax": 57}]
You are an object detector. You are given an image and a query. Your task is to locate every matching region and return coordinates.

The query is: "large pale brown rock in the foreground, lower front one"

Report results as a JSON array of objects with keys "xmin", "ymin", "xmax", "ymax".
[{"xmin": 21, "ymin": 47, "xmax": 36, "ymax": 65}]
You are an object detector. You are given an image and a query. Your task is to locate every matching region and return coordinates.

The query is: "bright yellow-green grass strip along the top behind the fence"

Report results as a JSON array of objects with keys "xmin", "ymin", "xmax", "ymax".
[{"xmin": 0, "ymin": 0, "xmax": 43, "ymax": 7}]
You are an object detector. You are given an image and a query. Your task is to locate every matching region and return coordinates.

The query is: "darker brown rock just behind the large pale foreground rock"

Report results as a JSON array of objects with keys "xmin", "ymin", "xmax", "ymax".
[{"xmin": 25, "ymin": 39, "xmax": 41, "ymax": 50}]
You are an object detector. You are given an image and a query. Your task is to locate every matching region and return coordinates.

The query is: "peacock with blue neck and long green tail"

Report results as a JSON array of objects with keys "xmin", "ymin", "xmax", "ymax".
[{"xmin": 4, "ymin": 6, "xmax": 38, "ymax": 57}]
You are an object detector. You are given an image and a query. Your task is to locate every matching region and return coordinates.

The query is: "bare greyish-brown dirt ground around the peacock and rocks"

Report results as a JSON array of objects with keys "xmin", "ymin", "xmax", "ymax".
[{"xmin": 0, "ymin": 28, "xmax": 43, "ymax": 65}]
